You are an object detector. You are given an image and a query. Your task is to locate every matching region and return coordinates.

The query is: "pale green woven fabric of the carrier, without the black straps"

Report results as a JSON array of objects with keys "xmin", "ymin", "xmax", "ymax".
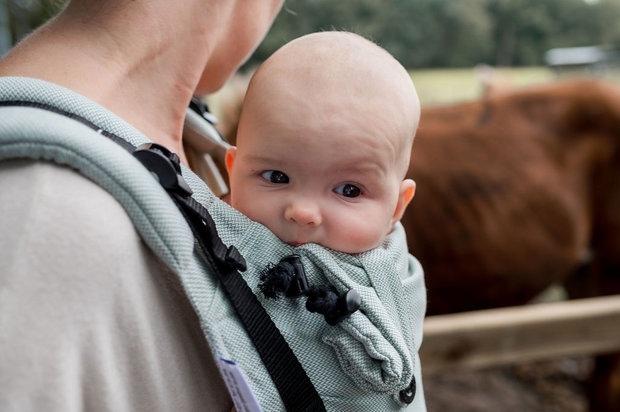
[{"xmin": 0, "ymin": 78, "xmax": 426, "ymax": 411}]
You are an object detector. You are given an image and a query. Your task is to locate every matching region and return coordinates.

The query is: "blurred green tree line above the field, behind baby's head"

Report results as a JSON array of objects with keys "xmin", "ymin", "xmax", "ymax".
[{"xmin": 252, "ymin": 0, "xmax": 620, "ymax": 68}]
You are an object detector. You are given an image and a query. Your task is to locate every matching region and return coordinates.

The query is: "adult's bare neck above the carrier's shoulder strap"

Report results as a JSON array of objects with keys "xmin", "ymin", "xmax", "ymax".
[{"xmin": 0, "ymin": 2, "xmax": 218, "ymax": 160}]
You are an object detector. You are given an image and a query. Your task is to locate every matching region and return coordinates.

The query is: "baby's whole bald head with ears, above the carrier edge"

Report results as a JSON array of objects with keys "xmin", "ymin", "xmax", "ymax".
[{"xmin": 226, "ymin": 32, "xmax": 420, "ymax": 253}]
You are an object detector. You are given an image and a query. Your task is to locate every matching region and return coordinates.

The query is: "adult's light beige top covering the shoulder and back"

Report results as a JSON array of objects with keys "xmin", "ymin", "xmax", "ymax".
[{"xmin": 0, "ymin": 160, "xmax": 231, "ymax": 411}]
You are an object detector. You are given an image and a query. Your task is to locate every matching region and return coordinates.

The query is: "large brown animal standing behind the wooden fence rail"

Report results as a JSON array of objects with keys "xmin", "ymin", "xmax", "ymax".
[{"xmin": 209, "ymin": 79, "xmax": 620, "ymax": 411}]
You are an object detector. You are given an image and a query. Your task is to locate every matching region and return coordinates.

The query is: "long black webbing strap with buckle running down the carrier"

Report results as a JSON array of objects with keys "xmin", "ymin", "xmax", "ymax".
[{"xmin": 0, "ymin": 101, "xmax": 325, "ymax": 412}]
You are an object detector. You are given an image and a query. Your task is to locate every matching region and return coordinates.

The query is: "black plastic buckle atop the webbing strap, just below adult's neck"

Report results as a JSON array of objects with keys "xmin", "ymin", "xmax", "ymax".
[{"xmin": 133, "ymin": 143, "xmax": 192, "ymax": 196}]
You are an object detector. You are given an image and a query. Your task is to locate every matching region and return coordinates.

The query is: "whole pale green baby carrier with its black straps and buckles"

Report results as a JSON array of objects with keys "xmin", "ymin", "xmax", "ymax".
[{"xmin": 0, "ymin": 78, "xmax": 426, "ymax": 411}]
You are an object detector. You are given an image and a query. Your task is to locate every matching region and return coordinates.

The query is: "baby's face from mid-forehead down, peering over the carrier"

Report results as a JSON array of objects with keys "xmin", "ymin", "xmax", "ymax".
[{"xmin": 227, "ymin": 93, "xmax": 414, "ymax": 253}]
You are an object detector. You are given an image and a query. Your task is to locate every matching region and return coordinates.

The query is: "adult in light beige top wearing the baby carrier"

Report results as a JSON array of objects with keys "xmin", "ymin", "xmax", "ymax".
[{"xmin": 0, "ymin": 0, "xmax": 282, "ymax": 411}]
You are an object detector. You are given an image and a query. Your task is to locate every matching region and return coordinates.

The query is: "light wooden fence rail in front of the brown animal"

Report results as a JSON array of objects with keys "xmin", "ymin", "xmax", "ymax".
[{"xmin": 420, "ymin": 295, "xmax": 620, "ymax": 375}]
